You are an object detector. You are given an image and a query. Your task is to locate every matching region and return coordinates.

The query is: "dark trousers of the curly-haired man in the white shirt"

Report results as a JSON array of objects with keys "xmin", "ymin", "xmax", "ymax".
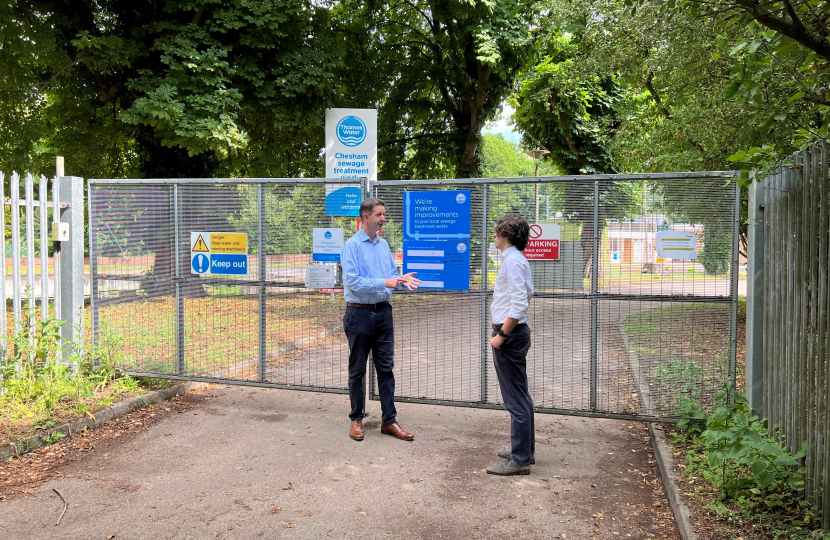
[{"xmin": 493, "ymin": 324, "xmax": 536, "ymax": 465}]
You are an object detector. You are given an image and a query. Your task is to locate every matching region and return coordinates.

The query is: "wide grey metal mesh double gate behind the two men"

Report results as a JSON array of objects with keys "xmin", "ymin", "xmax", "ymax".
[{"xmin": 89, "ymin": 172, "xmax": 740, "ymax": 421}]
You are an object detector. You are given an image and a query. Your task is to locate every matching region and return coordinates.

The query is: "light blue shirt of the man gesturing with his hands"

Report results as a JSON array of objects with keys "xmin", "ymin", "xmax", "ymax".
[{"xmin": 340, "ymin": 228, "xmax": 400, "ymax": 304}]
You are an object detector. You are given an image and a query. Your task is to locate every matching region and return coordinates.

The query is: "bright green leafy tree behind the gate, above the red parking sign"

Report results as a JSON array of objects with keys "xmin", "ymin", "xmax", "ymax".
[{"xmin": 511, "ymin": 13, "xmax": 640, "ymax": 275}]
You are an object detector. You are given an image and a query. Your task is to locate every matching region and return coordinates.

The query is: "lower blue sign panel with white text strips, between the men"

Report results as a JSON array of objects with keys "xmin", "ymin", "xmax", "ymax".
[{"xmin": 403, "ymin": 240, "xmax": 470, "ymax": 291}]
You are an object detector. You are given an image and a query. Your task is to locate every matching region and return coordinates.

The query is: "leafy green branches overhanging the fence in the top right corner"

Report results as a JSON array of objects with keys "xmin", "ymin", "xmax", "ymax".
[{"xmin": 648, "ymin": 0, "xmax": 830, "ymax": 176}]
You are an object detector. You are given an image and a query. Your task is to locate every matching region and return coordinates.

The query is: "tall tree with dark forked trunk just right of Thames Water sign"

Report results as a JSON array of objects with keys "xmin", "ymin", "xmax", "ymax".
[{"xmin": 340, "ymin": 0, "xmax": 537, "ymax": 178}]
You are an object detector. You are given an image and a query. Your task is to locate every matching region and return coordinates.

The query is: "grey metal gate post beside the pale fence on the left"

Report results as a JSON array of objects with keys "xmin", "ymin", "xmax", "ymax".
[{"xmin": 58, "ymin": 176, "xmax": 84, "ymax": 368}]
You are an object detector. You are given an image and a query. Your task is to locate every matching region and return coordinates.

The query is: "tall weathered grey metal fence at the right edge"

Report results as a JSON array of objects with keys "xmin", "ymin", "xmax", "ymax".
[{"xmin": 747, "ymin": 141, "xmax": 830, "ymax": 528}]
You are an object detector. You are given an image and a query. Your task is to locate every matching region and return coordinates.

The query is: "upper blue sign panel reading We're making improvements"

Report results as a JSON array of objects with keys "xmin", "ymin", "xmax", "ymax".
[{"xmin": 403, "ymin": 190, "xmax": 470, "ymax": 241}]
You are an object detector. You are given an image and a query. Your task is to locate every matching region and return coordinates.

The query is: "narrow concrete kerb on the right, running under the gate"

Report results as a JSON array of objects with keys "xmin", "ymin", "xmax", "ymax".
[{"xmin": 620, "ymin": 321, "xmax": 695, "ymax": 540}]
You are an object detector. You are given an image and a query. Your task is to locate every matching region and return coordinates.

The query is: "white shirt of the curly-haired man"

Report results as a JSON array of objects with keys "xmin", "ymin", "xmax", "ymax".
[{"xmin": 490, "ymin": 246, "xmax": 534, "ymax": 324}]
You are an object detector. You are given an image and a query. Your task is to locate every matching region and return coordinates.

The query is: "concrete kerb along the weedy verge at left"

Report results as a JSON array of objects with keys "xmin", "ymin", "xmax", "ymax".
[{"xmin": 0, "ymin": 382, "xmax": 204, "ymax": 461}]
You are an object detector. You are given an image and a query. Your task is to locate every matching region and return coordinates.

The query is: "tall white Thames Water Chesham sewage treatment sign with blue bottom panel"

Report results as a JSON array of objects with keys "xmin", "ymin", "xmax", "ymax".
[{"xmin": 326, "ymin": 109, "xmax": 378, "ymax": 216}]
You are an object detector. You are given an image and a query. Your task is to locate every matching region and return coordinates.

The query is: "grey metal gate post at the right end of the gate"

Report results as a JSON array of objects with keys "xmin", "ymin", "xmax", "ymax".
[{"xmin": 745, "ymin": 171, "xmax": 766, "ymax": 415}]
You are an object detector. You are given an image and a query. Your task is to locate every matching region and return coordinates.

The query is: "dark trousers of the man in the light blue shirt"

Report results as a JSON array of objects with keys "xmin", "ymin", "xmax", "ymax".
[{"xmin": 343, "ymin": 304, "xmax": 398, "ymax": 424}]
